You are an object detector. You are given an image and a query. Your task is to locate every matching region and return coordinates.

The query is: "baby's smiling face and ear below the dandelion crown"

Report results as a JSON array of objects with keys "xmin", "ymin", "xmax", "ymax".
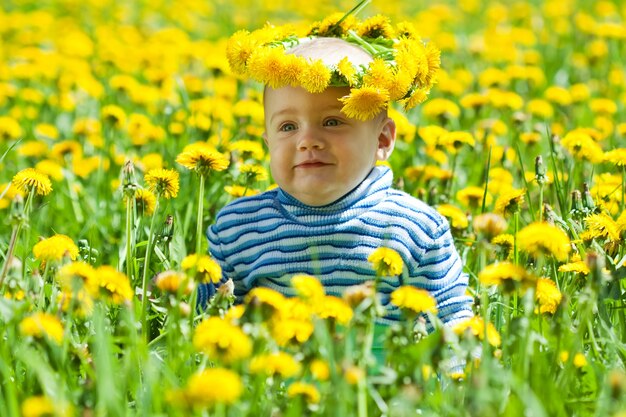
[{"xmin": 264, "ymin": 87, "xmax": 395, "ymax": 206}]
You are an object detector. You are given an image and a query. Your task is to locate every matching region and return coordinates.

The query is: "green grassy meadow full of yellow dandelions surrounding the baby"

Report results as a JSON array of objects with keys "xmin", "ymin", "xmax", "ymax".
[{"xmin": 0, "ymin": 0, "xmax": 626, "ymax": 417}]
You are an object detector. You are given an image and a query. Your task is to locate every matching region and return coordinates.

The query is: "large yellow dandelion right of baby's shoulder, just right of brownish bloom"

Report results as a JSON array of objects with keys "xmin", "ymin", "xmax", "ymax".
[{"xmin": 517, "ymin": 222, "xmax": 571, "ymax": 261}]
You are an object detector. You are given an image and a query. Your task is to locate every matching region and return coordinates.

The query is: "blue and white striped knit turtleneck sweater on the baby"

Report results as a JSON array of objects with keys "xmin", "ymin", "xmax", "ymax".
[{"xmin": 198, "ymin": 166, "xmax": 472, "ymax": 324}]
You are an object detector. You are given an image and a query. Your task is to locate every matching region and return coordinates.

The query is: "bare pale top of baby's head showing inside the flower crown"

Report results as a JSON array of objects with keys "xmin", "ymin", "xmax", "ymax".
[{"xmin": 287, "ymin": 38, "xmax": 373, "ymax": 67}]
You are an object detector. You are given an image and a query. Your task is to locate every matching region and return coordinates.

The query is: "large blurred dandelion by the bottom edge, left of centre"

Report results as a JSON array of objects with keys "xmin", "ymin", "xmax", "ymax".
[{"xmin": 185, "ymin": 368, "xmax": 244, "ymax": 407}]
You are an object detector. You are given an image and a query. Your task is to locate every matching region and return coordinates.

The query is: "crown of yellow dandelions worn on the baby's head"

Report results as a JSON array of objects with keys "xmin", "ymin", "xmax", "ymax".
[{"xmin": 226, "ymin": 0, "xmax": 440, "ymax": 120}]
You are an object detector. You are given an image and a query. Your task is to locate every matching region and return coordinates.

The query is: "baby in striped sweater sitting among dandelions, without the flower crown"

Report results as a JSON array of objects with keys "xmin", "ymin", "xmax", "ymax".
[{"xmin": 199, "ymin": 25, "xmax": 472, "ymax": 324}]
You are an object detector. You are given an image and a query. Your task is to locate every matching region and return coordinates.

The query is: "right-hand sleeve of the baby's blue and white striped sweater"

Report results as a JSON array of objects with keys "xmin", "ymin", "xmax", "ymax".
[{"xmin": 416, "ymin": 219, "xmax": 473, "ymax": 326}]
